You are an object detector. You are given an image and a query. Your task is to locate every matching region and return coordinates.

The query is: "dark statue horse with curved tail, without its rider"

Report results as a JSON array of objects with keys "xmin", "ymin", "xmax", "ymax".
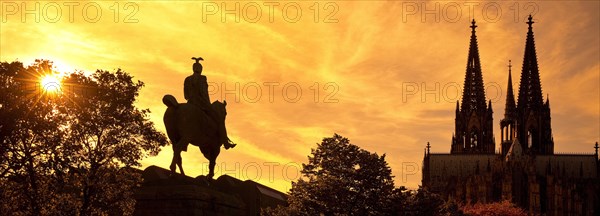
[{"xmin": 163, "ymin": 95, "xmax": 227, "ymax": 178}]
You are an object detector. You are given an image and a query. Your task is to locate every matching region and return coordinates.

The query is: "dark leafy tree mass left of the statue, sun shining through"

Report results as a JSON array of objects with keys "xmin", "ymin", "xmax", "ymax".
[{"xmin": 0, "ymin": 60, "xmax": 167, "ymax": 215}]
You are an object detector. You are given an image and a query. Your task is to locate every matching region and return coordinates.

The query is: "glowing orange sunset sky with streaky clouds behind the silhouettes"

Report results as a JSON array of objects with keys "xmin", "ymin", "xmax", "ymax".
[{"xmin": 0, "ymin": 1, "xmax": 600, "ymax": 191}]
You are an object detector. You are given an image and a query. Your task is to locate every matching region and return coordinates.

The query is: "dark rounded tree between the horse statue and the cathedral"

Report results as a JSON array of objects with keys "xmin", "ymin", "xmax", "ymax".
[{"xmin": 265, "ymin": 134, "xmax": 394, "ymax": 215}]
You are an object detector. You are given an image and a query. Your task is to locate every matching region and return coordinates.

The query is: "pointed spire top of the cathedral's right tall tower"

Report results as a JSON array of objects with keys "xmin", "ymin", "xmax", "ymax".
[{"xmin": 517, "ymin": 15, "xmax": 543, "ymax": 110}]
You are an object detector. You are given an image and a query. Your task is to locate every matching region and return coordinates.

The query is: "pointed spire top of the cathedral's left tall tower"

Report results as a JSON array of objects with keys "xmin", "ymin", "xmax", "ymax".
[{"xmin": 461, "ymin": 19, "xmax": 486, "ymax": 115}]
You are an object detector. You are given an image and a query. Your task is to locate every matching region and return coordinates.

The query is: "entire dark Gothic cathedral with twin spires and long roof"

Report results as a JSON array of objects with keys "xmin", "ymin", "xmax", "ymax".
[{"xmin": 422, "ymin": 16, "xmax": 600, "ymax": 215}]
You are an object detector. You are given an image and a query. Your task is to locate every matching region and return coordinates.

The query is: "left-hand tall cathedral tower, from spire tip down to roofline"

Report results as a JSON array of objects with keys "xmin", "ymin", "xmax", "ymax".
[{"xmin": 451, "ymin": 20, "xmax": 495, "ymax": 154}]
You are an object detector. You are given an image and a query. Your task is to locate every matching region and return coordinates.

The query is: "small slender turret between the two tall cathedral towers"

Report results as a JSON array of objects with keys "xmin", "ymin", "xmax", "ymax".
[{"xmin": 500, "ymin": 60, "xmax": 517, "ymax": 156}]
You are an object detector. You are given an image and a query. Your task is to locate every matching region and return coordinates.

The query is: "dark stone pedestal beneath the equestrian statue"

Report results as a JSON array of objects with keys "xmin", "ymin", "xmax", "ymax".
[{"xmin": 134, "ymin": 166, "xmax": 287, "ymax": 216}]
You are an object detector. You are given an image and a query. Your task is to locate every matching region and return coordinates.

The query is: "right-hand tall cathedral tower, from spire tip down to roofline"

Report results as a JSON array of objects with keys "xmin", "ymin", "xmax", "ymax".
[{"xmin": 517, "ymin": 15, "xmax": 554, "ymax": 154}]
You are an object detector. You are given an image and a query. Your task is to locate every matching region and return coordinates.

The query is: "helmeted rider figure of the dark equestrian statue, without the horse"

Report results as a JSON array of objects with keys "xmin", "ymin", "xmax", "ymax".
[{"xmin": 183, "ymin": 57, "xmax": 236, "ymax": 149}]
